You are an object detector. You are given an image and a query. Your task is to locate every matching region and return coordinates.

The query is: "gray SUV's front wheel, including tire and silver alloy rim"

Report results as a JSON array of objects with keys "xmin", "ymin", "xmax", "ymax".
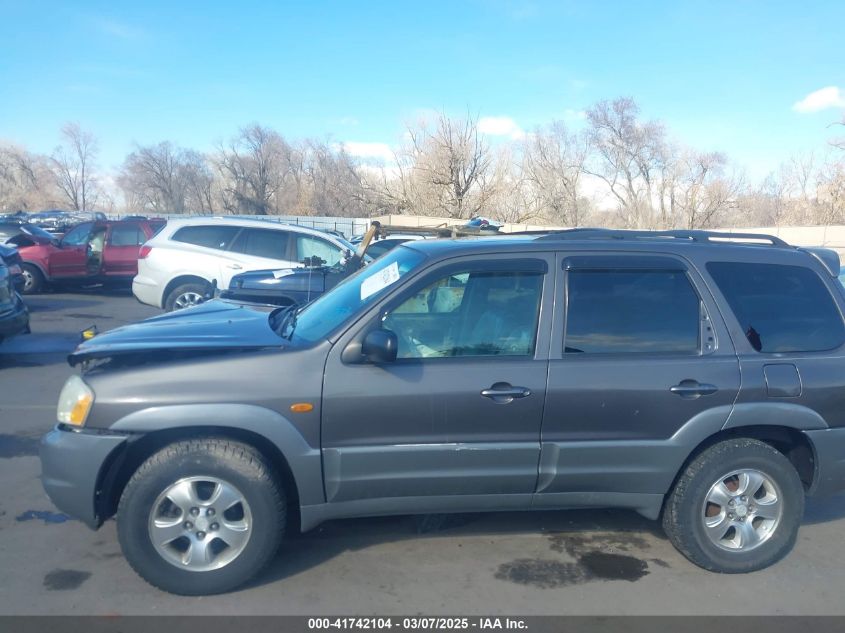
[{"xmin": 117, "ymin": 439, "xmax": 285, "ymax": 595}]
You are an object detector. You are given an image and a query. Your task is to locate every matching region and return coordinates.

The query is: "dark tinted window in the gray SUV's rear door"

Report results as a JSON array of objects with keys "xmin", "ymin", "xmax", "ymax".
[{"xmin": 564, "ymin": 270, "xmax": 702, "ymax": 354}]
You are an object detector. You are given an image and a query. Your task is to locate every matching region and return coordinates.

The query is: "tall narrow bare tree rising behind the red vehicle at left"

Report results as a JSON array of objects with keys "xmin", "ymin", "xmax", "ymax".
[{"xmin": 50, "ymin": 123, "xmax": 99, "ymax": 211}]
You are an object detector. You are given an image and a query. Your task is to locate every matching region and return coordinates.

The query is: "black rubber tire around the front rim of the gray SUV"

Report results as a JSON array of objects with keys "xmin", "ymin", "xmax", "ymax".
[{"xmin": 117, "ymin": 438, "xmax": 286, "ymax": 596}]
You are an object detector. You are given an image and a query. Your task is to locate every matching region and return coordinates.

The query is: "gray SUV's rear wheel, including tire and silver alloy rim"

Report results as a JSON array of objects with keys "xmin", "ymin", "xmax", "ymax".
[{"xmin": 663, "ymin": 438, "xmax": 804, "ymax": 573}]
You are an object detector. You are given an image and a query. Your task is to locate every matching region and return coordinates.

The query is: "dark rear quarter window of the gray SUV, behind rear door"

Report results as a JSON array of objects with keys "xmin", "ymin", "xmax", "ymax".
[{"xmin": 707, "ymin": 262, "xmax": 845, "ymax": 353}]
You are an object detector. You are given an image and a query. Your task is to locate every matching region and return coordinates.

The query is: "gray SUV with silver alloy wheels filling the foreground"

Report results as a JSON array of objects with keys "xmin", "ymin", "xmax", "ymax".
[{"xmin": 42, "ymin": 229, "xmax": 845, "ymax": 594}]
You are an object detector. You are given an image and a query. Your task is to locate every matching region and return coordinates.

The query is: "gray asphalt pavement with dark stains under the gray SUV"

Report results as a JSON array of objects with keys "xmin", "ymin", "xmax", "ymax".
[{"xmin": 0, "ymin": 291, "xmax": 845, "ymax": 615}]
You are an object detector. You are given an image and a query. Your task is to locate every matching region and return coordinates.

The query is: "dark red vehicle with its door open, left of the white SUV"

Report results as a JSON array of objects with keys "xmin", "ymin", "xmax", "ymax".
[{"xmin": 18, "ymin": 220, "xmax": 165, "ymax": 294}]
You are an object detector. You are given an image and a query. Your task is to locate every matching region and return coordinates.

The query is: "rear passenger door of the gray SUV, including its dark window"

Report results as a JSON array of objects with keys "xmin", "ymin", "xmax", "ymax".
[{"xmin": 535, "ymin": 252, "xmax": 740, "ymax": 505}]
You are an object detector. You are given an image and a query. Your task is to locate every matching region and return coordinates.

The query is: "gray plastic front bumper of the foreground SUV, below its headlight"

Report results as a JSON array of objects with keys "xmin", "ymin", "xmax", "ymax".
[{"xmin": 41, "ymin": 426, "xmax": 128, "ymax": 530}]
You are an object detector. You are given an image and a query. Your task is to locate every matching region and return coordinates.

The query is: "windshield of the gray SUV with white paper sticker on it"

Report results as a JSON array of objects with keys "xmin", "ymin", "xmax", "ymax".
[{"xmin": 294, "ymin": 247, "xmax": 425, "ymax": 342}]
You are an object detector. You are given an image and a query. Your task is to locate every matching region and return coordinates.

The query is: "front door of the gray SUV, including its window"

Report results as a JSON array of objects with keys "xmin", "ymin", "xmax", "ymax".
[{"xmin": 322, "ymin": 253, "xmax": 554, "ymax": 507}]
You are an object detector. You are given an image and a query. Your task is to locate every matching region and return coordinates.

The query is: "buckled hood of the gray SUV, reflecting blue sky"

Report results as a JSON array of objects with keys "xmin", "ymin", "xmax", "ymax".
[{"xmin": 68, "ymin": 300, "xmax": 287, "ymax": 366}]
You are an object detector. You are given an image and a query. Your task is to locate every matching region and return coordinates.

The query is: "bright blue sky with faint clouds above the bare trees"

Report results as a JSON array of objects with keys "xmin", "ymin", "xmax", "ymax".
[{"xmin": 0, "ymin": 0, "xmax": 845, "ymax": 177}]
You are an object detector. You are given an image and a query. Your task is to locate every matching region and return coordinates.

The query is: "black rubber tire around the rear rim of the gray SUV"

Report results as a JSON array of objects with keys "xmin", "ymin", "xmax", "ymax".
[{"xmin": 663, "ymin": 438, "xmax": 804, "ymax": 574}]
